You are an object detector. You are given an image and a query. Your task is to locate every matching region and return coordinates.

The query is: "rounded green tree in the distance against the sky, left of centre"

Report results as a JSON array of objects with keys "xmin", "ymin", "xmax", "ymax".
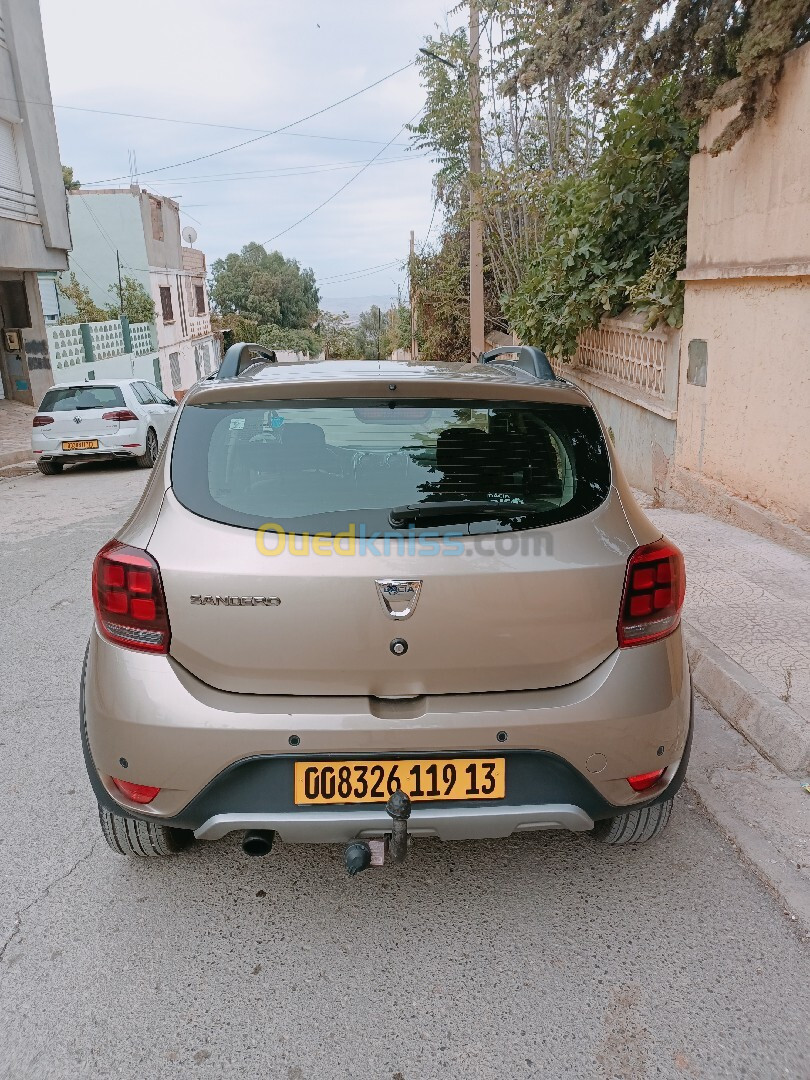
[{"xmin": 210, "ymin": 243, "xmax": 319, "ymax": 329}]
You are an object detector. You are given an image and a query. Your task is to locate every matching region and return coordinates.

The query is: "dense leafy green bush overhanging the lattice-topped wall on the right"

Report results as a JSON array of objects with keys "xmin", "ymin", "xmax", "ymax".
[{"xmin": 505, "ymin": 80, "xmax": 697, "ymax": 359}]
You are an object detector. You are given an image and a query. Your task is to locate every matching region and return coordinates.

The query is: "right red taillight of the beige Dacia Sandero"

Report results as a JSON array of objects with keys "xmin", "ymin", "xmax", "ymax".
[{"xmin": 618, "ymin": 540, "xmax": 686, "ymax": 649}]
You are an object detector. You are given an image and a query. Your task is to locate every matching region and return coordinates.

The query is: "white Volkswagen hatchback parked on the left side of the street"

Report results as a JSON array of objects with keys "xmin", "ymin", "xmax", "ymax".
[{"xmin": 31, "ymin": 379, "xmax": 177, "ymax": 476}]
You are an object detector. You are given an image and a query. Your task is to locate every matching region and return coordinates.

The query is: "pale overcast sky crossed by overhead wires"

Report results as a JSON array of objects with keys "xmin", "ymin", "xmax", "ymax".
[{"xmin": 40, "ymin": 0, "xmax": 457, "ymax": 313}]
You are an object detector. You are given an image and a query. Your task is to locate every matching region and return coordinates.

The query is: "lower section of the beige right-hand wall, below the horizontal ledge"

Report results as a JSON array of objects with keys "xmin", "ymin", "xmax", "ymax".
[{"xmin": 675, "ymin": 278, "xmax": 810, "ymax": 529}]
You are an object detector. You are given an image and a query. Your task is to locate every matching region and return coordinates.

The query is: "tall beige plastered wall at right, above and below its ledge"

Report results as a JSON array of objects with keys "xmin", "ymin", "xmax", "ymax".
[{"xmin": 673, "ymin": 45, "xmax": 810, "ymax": 529}]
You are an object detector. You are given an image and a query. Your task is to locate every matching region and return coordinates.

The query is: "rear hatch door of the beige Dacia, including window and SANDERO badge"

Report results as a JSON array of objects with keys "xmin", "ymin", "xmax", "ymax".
[{"xmin": 149, "ymin": 393, "xmax": 635, "ymax": 697}]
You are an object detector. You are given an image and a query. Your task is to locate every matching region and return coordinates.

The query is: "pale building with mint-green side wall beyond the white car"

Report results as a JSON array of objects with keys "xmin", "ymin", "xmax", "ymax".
[{"xmin": 62, "ymin": 185, "xmax": 219, "ymax": 399}]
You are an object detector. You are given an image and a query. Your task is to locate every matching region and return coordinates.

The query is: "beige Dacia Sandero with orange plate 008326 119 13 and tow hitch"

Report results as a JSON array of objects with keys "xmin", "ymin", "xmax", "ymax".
[{"xmin": 81, "ymin": 345, "xmax": 692, "ymax": 873}]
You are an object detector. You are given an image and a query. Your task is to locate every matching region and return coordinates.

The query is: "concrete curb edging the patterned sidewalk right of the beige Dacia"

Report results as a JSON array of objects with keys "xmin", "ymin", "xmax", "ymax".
[{"xmin": 684, "ymin": 623, "xmax": 810, "ymax": 779}]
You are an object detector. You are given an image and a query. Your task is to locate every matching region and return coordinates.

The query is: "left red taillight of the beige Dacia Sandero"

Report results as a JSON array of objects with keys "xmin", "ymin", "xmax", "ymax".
[{"xmin": 93, "ymin": 540, "xmax": 171, "ymax": 652}]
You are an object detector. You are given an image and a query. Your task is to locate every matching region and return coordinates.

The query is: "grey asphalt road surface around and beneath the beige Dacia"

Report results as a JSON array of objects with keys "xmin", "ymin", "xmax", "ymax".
[{"xmin": 0, "ymin": 463, "xmax": 810, "ymax": 1080}]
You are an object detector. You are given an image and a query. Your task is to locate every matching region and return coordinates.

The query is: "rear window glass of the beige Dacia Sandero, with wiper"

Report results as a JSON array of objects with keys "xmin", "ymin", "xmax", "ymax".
[{"xmin": 172, "ymin": 399, "xmax": 610, "ymax": 536}]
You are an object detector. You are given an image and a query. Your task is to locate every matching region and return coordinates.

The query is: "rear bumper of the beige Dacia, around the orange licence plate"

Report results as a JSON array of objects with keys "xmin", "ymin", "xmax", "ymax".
[{"xmin": 82, "ymin": 630, "xmax": 691, "ymax": 842}]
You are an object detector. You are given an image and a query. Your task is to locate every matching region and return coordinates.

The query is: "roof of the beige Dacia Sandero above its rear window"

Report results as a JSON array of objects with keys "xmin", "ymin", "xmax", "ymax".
[{"xmin": 185, "ymin": 360, "xmax": 584, "ymax": 404}]
